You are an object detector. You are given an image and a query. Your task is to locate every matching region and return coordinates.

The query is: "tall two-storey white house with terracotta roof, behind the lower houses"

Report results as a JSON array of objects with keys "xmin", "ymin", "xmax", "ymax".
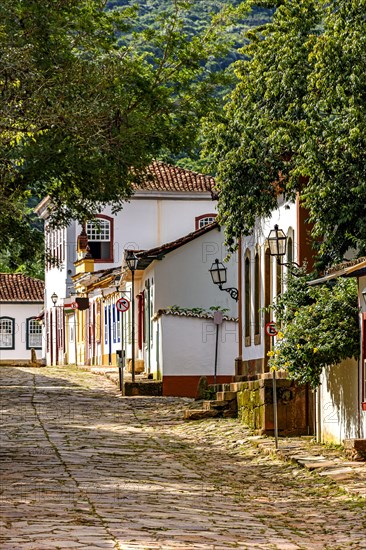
[{"xmin": 36, "ymin": 162, "xmax": 217, "ymax": 365}]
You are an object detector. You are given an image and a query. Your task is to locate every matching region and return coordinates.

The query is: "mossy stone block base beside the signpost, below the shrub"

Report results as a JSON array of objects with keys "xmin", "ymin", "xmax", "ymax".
[{"xmin": 237, "ymin": 373, "xmax": 313, "ymax": 436}]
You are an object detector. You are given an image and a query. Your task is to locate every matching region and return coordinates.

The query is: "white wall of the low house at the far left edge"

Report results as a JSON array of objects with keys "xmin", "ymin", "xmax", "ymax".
[{"xmin": 0, "ymin": 303, "xmax": 42, "ymax": 362}]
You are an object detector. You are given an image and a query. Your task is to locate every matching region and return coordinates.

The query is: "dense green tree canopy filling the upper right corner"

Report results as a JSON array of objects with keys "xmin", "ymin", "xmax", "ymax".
[{"xmin": 206, "ymin": 0, "xmax": 366, "ymax": 261}]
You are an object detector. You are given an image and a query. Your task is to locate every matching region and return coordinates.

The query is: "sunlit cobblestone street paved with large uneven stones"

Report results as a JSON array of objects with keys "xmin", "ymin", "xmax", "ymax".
[{"xmin": 0, "ymin": 367, "xmax": 366, "ymax": 550}]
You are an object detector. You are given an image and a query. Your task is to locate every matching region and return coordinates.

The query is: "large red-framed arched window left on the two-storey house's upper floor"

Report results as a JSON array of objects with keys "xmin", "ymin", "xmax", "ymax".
[{"xmin": 85, "ymin": 216, "xmax": 113, "ymax": 262}]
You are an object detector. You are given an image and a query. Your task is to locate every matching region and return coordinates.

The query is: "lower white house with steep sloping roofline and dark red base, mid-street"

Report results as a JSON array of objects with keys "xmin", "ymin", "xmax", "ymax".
[{"xmin": 66, "ymin": 222, "xmax": 239, "ymax": 396}]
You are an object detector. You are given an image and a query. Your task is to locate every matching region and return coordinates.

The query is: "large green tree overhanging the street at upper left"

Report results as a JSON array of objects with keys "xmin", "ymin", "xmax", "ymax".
[{"xmin": 0, "ymin": 0, "xmax": 243, "ymax": 231}]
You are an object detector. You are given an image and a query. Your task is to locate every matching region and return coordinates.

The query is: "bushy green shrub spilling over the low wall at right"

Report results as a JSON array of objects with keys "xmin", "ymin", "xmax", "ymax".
[{"xmin": 269, "ymin": 271, "xmax": 360, "ymax": 388}]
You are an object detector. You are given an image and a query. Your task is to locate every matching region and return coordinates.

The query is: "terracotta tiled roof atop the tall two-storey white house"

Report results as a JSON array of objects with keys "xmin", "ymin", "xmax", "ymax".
[{"xmin": 136, "ymin": 161, "xmax": 215, "ymax": 194}]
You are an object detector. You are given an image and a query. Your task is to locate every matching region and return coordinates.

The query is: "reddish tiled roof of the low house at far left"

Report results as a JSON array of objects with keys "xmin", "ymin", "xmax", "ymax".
[{"xmin": 0, "ymin": 273, "xmax": 44, "ymax": 302}]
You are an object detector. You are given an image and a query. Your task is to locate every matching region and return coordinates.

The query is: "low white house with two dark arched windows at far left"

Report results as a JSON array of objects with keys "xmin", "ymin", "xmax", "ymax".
[{"xmin": 0, "ymin": 273, "xmax": 44, "ymax": 365}]
